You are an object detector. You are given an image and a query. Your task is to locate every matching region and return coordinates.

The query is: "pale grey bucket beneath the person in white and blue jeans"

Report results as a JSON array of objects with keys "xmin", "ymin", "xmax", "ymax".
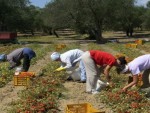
[{"xmin": 67, "ymin": 68, "xmax": 80, "ymax": 81}]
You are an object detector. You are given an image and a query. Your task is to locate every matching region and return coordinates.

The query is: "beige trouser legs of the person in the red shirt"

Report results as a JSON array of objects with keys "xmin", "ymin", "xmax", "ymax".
[{"xmin": 82, "ymin": 51, "xmax": 98, "ymax": 92}]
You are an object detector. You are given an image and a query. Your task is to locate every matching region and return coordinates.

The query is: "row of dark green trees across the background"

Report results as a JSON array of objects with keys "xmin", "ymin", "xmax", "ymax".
[{"xmin": 0, "ymin": 0, "xmax": 150, "ymax": 42}]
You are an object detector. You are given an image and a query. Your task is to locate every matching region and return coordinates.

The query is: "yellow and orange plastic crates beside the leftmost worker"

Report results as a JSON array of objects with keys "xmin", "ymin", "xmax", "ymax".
[{"xmin": 13, "ymin": 72, "xmax": 35, "ymax": 87}]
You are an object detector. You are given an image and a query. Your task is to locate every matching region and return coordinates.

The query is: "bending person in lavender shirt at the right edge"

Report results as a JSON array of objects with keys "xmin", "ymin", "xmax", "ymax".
[{"xmin": 118, "ymin": 54, "xmax": 150, "ymax": 92}]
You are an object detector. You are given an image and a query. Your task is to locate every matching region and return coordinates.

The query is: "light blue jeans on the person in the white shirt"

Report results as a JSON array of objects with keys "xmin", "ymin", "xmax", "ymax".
[{"xmin": 79, "ymin": 60, "xmax": 86, "ymax": 81}]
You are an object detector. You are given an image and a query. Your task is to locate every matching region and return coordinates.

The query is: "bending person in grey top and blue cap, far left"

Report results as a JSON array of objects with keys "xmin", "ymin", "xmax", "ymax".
[{"xmin": 0, "ymin": 48, "xmax": 36, "ymax": 72}]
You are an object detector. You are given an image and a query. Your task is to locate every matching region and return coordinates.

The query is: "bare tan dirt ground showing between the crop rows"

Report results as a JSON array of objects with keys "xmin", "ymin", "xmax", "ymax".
[{"xmin": 0, "ymin": 36, "xmax": 150, "ymax": 113}]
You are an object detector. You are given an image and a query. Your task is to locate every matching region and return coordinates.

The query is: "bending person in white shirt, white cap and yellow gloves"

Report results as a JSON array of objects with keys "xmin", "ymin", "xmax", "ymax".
[{"xmin": 50, "ymin": 49, "xmax": 86, "ymax": 83}]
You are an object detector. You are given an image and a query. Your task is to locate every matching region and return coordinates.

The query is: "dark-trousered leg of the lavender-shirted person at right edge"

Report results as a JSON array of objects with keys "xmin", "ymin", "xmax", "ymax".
[{"xmin": 141, "ymin": 69, "xmax": 150, "ymax": 88}]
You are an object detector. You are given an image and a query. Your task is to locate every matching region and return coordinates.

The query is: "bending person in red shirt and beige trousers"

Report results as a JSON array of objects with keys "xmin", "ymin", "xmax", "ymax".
[{"xmin": 81, "ymin": 50, "xmax": 126, "ymax": 94}]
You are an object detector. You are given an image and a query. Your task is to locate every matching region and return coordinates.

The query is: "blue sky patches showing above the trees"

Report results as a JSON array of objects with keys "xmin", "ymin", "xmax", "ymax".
[{"xmin": 30, "ymin": 0, "xmax": 150, "ymax": 8}]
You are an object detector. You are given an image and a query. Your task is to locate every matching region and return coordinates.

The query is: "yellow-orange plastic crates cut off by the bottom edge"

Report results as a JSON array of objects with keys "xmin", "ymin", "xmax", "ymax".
[{"xmin": 66, "ymin": 103, "xmax": 105, "ymax": 113}]
